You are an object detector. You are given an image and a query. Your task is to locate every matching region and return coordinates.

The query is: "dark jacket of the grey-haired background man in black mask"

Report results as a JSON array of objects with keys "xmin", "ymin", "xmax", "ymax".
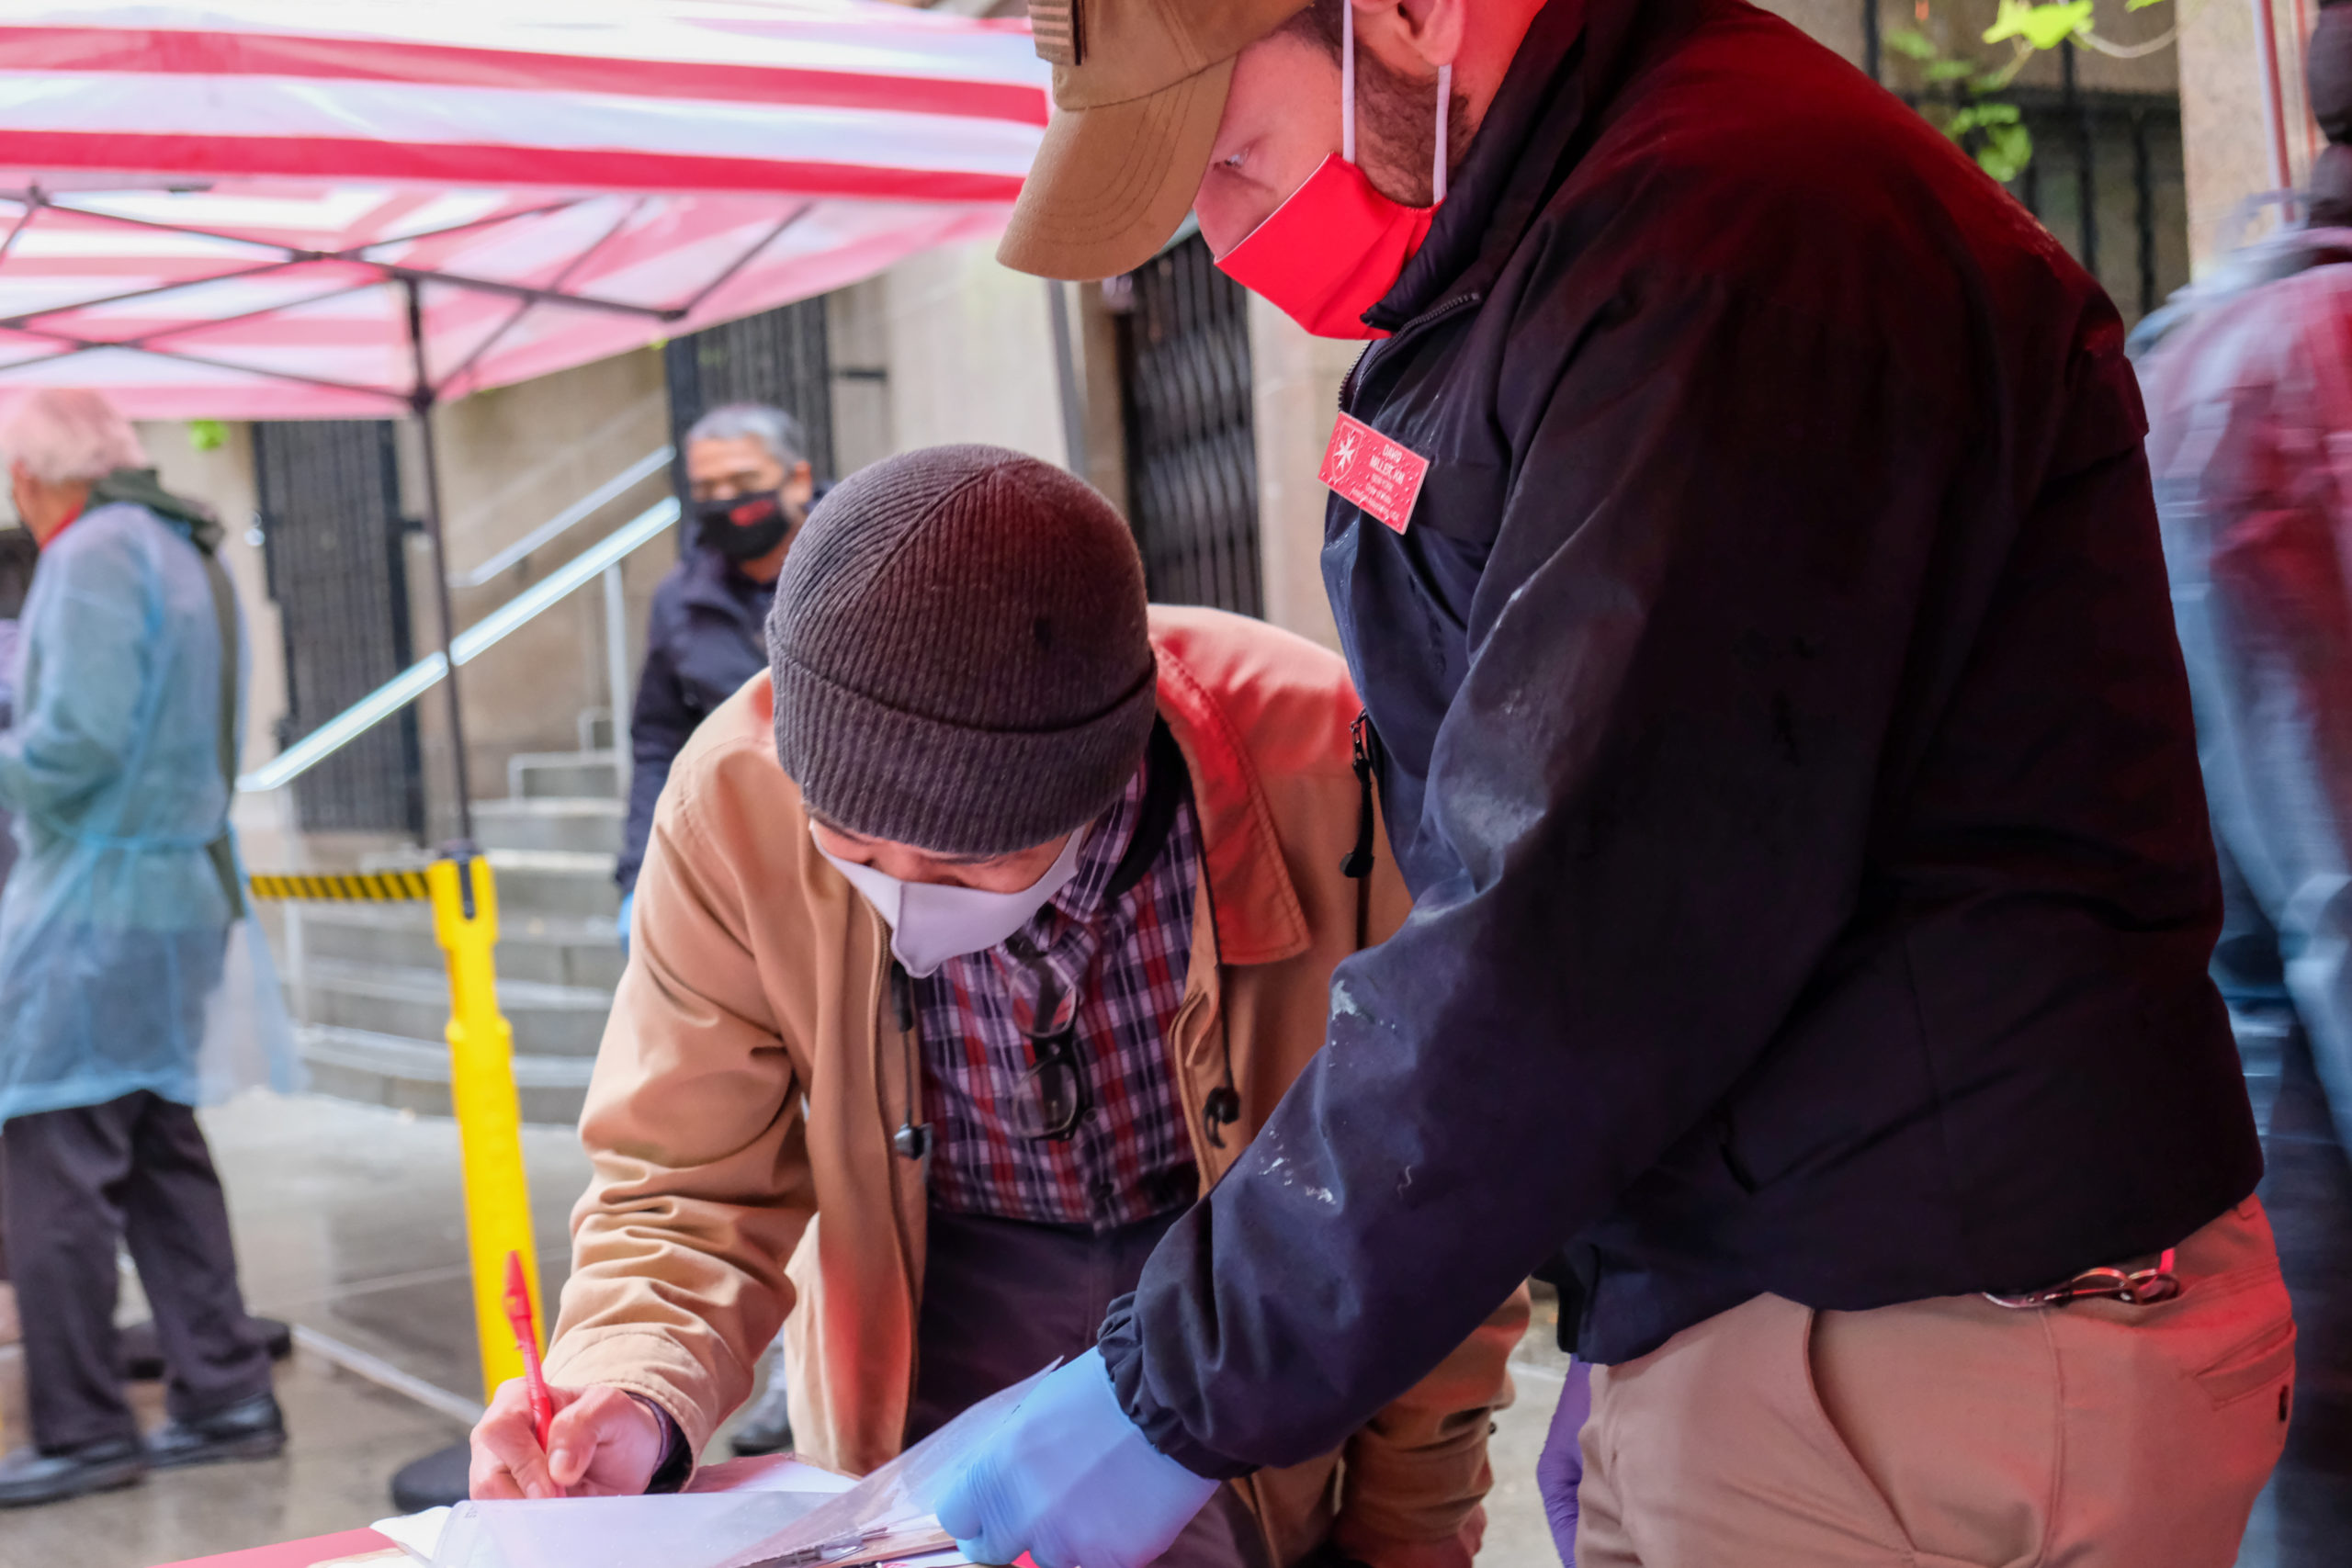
[{"xmin": 616, "ymin": 546, "xmax": 776, "ymax": 894}]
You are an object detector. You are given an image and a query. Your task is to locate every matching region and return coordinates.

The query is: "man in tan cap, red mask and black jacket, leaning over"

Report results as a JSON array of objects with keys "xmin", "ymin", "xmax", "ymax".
[{"xmin": 941, "ymin": 0, "xmax": 2293, "ymax": 1568}]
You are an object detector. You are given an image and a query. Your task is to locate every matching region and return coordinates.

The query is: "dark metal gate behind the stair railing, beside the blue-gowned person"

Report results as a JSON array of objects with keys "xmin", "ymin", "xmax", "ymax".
[{"xmin": 254, "ymin": 419, "xmax": 425, "ymax": 835}]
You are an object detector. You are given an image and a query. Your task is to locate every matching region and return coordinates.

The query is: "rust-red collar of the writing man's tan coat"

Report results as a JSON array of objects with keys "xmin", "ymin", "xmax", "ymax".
[{"xmin": 1152, "ymin": 627, "xmax": 1312, "ymax": 964}]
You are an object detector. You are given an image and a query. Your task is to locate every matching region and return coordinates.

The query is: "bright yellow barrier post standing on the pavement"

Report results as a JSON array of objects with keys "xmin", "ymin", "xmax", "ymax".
[{"xmin": 425, "ymin": 856, "xmax": 548, "ymax": 1401}]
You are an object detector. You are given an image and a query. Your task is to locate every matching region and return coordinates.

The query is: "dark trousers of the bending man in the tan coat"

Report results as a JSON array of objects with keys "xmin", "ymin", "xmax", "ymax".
[{"xmin": 906, "ymin": 1208, "xmax": 1265, "ymax": 1568}]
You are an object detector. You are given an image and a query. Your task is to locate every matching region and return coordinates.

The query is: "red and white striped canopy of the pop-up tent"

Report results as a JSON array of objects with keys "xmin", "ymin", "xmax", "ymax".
[{"xmin": 0, "ymin": 0, "xmax": 1046, "ymax": 419}]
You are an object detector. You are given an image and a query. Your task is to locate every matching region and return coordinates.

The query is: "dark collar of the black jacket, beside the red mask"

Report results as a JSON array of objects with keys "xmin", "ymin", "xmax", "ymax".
[{"xmin": 1364, "ymin": 0, "xmax": 1656, "ymax": 332}]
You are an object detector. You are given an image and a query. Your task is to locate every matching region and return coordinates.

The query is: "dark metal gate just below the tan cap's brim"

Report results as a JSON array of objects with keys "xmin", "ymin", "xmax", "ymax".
[{"xmin": 1120, "ymin": 235, "xmax": 1263, "ymax": 616}]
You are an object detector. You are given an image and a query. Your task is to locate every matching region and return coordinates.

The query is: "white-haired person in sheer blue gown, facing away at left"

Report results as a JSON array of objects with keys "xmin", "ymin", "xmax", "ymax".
[{"xmin": 0, "ymin": 390, "xmax": 291, "ymax": 1505}]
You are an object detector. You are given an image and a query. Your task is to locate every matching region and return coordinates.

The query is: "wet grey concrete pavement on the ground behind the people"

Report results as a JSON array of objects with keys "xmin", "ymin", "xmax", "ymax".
[{"xmin": 0, "ymin": 1096, "xmax": 1562, "ymax": 1568}]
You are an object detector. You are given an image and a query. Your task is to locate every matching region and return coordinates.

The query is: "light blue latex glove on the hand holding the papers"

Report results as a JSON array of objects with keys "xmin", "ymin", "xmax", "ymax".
[{"xmin": 938, "ymin": 1349, "xmax": 1218, "ymax": 1568}]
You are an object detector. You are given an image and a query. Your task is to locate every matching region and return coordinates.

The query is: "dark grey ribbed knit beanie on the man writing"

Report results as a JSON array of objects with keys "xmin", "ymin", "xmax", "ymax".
[{"xmin": 767, "ymin": 446, "xmax": 1155, "ymax": 856}]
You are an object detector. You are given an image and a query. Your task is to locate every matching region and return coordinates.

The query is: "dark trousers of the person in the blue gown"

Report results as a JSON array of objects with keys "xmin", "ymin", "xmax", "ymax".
[{"xmin": 0, "ymin": 1090, "xmax": 270, "ymax": 1450}]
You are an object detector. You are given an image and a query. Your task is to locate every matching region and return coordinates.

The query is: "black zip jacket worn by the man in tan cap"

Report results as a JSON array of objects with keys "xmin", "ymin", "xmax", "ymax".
[{"xmin": 1105, "ymin": 0, "xmax": 2260, "ymax": 1474}]
